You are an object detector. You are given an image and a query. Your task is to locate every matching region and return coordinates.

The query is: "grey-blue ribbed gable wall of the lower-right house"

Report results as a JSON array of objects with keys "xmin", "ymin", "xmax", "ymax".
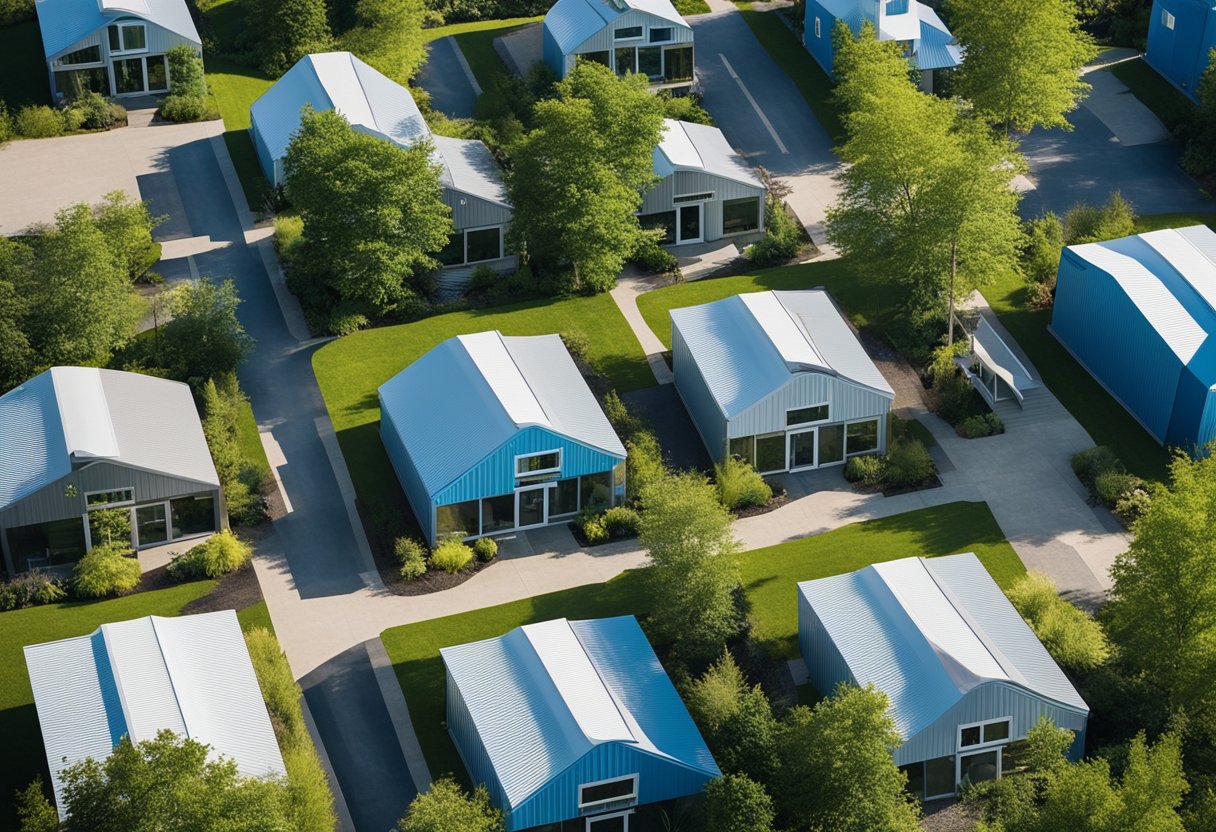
[{"xmin": 895, "ymin": 681, "xmax": 1087, "ymax": 765}]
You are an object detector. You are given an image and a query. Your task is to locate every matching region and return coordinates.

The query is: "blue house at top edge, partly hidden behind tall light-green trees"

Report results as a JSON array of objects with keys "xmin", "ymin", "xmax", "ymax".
[{"xmin": 803, "ymin": 0, "xmax": 963, "ymax": 91}]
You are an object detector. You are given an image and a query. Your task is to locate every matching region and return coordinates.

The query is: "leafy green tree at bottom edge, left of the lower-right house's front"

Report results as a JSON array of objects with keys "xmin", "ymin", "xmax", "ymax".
[{"xmin": 773, "ymin": 685, "xmax": 919, "ymax": 832}]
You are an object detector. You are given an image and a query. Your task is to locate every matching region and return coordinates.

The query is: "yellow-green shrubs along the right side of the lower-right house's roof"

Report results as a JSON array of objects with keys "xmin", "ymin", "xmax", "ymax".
[{"xmin": 1007, "ymin": 572, "xmax": 1110, "ymax": 670}]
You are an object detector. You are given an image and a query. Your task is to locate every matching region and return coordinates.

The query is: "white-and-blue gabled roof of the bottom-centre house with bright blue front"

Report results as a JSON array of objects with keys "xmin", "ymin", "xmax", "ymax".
[{"xmin": 439, "ymin": 615, "xmax": 720, "ymax": 808}]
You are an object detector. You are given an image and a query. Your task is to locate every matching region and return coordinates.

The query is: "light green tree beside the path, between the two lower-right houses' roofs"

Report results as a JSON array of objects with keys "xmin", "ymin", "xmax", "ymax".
[{"xmin": 638, "ymin": 472, "xmax": 739, "ymax": 663}]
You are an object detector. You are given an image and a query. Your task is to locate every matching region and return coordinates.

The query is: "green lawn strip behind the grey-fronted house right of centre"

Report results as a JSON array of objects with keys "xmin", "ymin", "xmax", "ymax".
[{"xmin": 637, "ymin": 260, "xmax": 895, "ymax": 348}]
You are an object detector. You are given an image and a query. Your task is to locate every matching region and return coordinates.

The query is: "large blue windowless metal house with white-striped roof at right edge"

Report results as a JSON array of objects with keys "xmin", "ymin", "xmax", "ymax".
[{"xmin": 1051, "ymin": 225, "xmax": 1216, "ymax": 452}]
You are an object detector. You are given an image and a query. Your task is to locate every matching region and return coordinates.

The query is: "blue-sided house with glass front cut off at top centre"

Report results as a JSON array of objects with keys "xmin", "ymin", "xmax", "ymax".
[{"xmin": 542, "ymin": 0, "xmax": 694, "ymax": 91}]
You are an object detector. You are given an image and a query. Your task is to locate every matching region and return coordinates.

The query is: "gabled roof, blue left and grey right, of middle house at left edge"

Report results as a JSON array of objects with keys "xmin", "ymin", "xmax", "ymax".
[{"xmin": 0, "ymin": 367, "xmax": 219, "ymax": 511}]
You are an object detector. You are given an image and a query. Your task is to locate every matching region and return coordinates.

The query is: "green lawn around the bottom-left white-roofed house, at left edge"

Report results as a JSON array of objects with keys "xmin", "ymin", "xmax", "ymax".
[{"xmin": 0, "ymin": 580, "xmax": 215, "ymax": 828}]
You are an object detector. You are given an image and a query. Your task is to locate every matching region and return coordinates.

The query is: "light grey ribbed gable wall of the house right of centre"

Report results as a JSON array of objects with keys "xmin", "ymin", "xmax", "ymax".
[{"xmin": 727, "ymin": 372, "xmax": 891, "ymax": 442}]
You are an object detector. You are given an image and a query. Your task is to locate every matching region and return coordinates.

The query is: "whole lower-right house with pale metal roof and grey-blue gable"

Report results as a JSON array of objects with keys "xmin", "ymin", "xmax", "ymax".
[{"xmin": 798, "ymin": 552, "xmax": 1090, "ymax": 799}]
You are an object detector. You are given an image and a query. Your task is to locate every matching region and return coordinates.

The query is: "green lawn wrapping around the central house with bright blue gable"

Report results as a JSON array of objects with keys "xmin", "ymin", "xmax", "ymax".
[{"xmin": 313, "ymin": 294, "xmax": 654, "ymax": 538}]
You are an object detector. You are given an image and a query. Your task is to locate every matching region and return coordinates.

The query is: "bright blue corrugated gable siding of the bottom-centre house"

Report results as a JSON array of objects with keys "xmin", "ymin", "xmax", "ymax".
[{"xmin": 507, "ymin": 742, "xmax": 710, "ymax": 832}]
